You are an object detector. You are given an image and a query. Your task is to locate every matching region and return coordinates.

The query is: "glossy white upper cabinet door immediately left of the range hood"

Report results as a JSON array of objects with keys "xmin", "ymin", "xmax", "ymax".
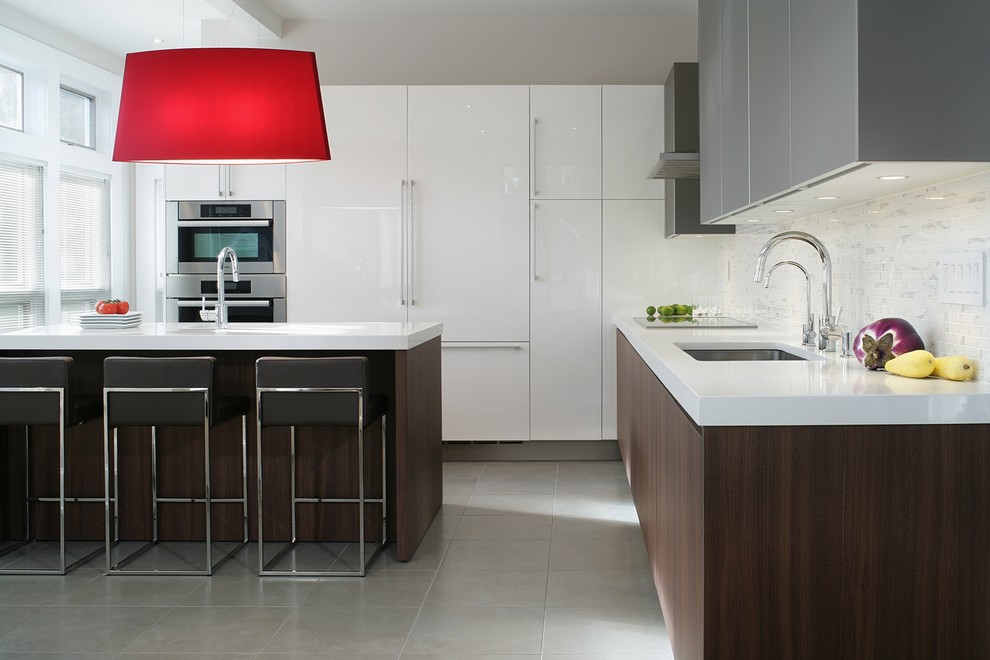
[{"xmin": 602, "ymin": 85, "xmax": 664, "ymax": 199}]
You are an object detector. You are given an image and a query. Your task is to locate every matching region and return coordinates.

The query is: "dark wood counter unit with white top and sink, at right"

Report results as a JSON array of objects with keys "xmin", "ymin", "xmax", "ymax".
[{"xmin": 614, "ymin": 316, "xmax": 990, "ymax": 660}]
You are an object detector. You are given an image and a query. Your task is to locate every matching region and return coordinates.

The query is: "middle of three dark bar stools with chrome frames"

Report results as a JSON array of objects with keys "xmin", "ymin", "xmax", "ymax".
[{"xmin": 103, "ymin": 357, "xmax": 250, "ymax": 575}]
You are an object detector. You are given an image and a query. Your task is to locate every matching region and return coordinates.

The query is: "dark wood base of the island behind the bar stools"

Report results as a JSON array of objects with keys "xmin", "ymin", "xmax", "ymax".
[{"xmin": 0, "ymin": 337, "xmax": 442, "ymax": 561}]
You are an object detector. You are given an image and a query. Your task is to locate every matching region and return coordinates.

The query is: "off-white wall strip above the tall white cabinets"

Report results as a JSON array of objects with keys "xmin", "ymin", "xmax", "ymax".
[{"xmin": 202, "ymin": 16, "xmax": 698, "ymax": 85}]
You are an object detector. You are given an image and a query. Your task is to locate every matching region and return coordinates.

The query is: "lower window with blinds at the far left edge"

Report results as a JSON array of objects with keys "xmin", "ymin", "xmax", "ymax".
[{"xmin": 0, "ymin": 159, "xmax": 45, "ymax": 331}]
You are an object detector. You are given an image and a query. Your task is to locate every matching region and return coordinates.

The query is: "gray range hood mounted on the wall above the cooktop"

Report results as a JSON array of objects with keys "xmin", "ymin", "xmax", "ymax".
[{"xmin": 651, "ymin": 62, "xmax": 736, "ymax": 238}]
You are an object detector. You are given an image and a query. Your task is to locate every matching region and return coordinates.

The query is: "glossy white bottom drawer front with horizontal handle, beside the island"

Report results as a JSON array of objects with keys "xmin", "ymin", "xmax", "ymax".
[{"xmin": 441, "ymin": 342, "xmax": 529, "ymax": 441}]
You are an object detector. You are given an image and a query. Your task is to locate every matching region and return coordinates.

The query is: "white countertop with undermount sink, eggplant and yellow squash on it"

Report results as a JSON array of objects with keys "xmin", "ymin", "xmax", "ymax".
[{"xmin": 613, "ymin": 314, "xmax": 990, "ymax": 426}]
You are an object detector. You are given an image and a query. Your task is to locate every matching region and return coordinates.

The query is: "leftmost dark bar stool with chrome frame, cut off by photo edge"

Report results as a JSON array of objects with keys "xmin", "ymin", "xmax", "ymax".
[{"xmin": 0, "ymin": 357, "xmax": 105, "ymax": 575}]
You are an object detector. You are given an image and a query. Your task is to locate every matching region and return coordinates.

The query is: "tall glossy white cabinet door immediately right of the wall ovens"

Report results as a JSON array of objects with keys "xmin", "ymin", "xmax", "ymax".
[{"xmin": 286, "ymin": 86, "xmax": 406, "ymax": 322}]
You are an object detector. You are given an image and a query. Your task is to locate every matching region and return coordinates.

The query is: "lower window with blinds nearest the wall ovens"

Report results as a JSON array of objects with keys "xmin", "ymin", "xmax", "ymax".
[{"xmin": 59, "ymin": 172, "xmax": 110, "ymax": 323}]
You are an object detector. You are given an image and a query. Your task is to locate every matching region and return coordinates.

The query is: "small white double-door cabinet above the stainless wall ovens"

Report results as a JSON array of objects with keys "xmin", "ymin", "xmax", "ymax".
[{"xmin": 165, "ymin": 165, "xmax": 286, "ymax": 200}]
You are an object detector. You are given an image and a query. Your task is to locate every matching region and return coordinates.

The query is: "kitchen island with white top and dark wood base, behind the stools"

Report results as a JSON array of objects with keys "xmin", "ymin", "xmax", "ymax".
[{"xmin": 0, "ymin": 323, "xmax": 443, "ymax": 560}]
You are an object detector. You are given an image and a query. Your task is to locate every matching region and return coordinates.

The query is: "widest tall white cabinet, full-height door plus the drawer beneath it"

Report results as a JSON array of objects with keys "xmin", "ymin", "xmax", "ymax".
[{"xmin": 407, "ymin": 86, "xmax": 530, "ymax": 441}]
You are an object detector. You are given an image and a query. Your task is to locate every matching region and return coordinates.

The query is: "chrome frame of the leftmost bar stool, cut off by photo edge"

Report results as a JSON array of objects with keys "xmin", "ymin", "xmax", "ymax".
[{"xmin": 0, "ymin": 357, "xmax": 106, "ymax": 575}]
